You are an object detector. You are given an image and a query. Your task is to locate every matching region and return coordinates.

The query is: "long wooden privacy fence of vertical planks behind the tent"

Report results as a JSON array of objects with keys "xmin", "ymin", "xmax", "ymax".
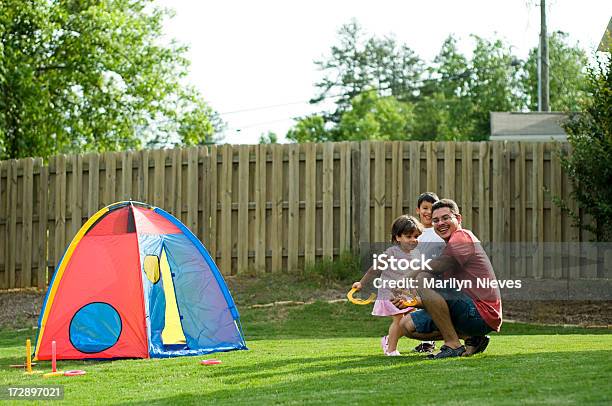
[{"xmin": 0, "ymin": 142, "xmax": 597, "ymax": 289}]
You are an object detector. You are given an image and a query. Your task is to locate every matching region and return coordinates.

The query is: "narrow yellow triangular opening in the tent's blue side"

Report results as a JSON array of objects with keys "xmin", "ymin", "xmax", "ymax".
[{"xmin": 159, "ymin": 247, "xmax": 187, "ymax": 345}]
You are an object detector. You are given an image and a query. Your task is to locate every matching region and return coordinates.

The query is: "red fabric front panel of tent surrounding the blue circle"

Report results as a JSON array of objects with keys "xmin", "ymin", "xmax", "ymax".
[{"xmin": 37, "ymin": 233, "xmax": 149, "ymax": 360}]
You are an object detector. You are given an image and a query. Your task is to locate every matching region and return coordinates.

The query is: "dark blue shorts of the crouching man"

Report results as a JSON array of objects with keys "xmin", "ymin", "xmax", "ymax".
[{"xmin": 409, "ymin": 289, "xmax": 493, "ymax": 336}]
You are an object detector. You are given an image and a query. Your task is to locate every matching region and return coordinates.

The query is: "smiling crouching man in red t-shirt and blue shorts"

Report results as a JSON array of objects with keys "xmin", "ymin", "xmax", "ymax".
[{"xmin": 393, "ymin": 199, "xmax": 502, "ymax": 359}]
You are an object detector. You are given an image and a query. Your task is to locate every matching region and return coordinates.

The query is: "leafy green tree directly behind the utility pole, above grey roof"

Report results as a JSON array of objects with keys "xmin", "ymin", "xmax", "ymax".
[{"xmin": 521, "ymin": 31, "xmax": 588, "ymax": 111}]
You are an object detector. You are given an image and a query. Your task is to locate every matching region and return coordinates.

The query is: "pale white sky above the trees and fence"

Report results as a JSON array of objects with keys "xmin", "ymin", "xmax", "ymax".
[{"xmin": 155, "ymin": 0, "xmax": 612, "ymax": 144}]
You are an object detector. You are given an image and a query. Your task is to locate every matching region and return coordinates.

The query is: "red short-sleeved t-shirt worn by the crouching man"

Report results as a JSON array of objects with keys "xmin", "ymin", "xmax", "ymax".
[{"xmin": 443, "ymin": 229, "xmax": 502, "ymax": 331}]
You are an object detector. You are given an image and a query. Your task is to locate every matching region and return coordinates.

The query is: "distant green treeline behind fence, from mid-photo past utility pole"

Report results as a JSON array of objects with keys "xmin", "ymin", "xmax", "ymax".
[{"xmin": 288, "ymin": 20, "xmax": 586, "ymax": 142}]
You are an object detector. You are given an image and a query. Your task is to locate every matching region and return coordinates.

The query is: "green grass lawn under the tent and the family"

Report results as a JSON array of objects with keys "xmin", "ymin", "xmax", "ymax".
[{"xmin": 0, "ymin": 303, "xmax": 612, "ymax": 405}]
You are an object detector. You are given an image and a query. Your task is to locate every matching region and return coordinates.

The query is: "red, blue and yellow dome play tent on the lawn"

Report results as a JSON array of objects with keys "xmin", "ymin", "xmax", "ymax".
[{"xmin": 35, "ymin": 201, "xmax": 246, "ymax": 360}]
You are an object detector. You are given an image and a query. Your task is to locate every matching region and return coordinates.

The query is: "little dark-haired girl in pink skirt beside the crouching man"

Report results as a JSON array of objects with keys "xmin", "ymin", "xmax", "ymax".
[{"xmin": 353, "ymin": 214, "xmax": 423, "ymax": 356}]
